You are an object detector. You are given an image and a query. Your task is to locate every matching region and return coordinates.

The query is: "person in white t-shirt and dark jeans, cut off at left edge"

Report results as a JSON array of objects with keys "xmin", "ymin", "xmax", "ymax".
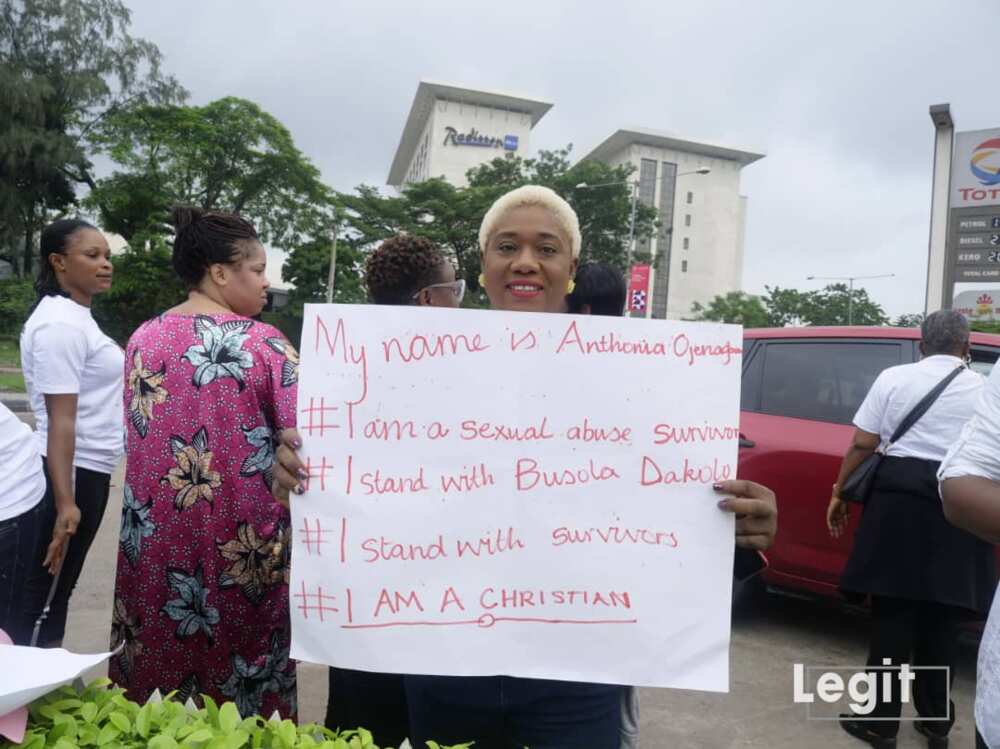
[{"xmin": 0, "ymin": 403, "xmax": 45, "ymax": 645}]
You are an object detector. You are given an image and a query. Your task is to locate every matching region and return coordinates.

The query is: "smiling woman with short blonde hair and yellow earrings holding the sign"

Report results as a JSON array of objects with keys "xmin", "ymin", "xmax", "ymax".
[{"xmin": 275, "ymin": 186, "xmax": 776, "ymax": 749}]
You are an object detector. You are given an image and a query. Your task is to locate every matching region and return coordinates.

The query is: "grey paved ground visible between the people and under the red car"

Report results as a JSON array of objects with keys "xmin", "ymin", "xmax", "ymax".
[{"xmin": 52, "ymin": 458, "xmax": 975, "ymax": 749}]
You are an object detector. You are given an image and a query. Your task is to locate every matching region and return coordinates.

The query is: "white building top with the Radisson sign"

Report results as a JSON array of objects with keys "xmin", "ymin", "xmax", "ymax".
[{"xmin": 387, "ymin": 81, "xmax": 552, "ymax": 187}]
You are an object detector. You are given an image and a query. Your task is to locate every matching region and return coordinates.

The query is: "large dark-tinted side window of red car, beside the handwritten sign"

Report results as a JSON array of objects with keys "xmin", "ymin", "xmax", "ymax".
[{"xmin": 758, "ymin": 341, "xmax": 902, "ymax": 424}]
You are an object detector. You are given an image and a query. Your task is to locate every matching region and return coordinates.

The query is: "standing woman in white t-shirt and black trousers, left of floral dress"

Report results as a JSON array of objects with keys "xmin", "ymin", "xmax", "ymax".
[{"xmin": 21, "ymin": 219, "xmax": 125, "ymax": 646}]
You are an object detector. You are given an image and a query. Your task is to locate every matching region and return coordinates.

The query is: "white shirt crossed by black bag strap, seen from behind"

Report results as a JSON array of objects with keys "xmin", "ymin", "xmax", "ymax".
[{"xmin": 854, "ymin": 355, "xmax": 983, "ymax": 461}]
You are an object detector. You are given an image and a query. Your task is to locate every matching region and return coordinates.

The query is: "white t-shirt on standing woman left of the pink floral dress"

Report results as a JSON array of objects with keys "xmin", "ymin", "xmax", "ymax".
[{"xmin": 21, "ymin": 296, "xmax": 125, "ymax": 473}]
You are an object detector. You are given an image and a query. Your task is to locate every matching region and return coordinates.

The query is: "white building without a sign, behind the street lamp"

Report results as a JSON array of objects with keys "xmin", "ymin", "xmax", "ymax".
[{"xmin": 584, "ymin": 128, "xmax": 764, "ymax": 319}]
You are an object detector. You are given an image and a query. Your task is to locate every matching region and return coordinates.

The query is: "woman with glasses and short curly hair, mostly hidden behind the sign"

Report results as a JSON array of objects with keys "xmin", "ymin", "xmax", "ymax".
[{"xmin": 326, "ymin": 234, "xmax": 465, "ymax": 746}]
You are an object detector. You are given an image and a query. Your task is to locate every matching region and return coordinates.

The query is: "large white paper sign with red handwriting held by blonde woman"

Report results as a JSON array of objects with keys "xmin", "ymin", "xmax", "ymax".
[{"xmin": 290, "ymin": 305, "xmax": 742, "ymax": 691}]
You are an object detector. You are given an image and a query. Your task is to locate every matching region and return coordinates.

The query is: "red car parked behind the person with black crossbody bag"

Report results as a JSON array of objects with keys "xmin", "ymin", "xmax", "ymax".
[{"xmin": 739, "ymin": 327, "xmax": 1000, "ymax": 596}]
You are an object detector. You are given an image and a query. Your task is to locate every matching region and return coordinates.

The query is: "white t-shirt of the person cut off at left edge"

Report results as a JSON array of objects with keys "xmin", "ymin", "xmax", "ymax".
[{"xmin": 0, "ymin": 403, "xmax": 45, "ymax": 521}]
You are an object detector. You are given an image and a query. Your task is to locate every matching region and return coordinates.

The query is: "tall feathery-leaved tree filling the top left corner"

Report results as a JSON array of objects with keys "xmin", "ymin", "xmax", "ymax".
[{"xmin": 0, "ymin": 0, "xmax": 186, "ymax": 275}]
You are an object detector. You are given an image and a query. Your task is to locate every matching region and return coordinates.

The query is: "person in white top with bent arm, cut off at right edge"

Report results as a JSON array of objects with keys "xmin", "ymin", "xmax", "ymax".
[{"xmin": 938, "ymin": 366, "xmax": 1000, "ymax": 749}]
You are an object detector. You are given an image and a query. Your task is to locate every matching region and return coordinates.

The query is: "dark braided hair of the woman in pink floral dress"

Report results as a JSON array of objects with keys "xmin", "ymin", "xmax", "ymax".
[{"xmin": 172, "ymin": 206, "xmax": 257, "ymax": 289}]
